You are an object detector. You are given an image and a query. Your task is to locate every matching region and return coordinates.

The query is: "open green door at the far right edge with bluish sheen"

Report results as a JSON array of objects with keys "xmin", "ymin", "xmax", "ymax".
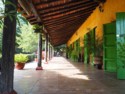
[{"xmin": 116, "ymin": 12, "xmax": 125, "ymax": 79}]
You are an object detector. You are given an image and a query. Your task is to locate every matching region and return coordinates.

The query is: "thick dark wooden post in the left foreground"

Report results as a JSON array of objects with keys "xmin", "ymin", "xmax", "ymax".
[{"xmin": 0, "ymin": 0, "xmax": 17, "ymax": 94}]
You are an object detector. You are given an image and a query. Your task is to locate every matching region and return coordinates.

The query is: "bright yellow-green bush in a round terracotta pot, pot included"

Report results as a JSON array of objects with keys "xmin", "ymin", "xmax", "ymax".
[{"xmin": 14, "ymin": 54, "xmax": 28, "ymax": 70}]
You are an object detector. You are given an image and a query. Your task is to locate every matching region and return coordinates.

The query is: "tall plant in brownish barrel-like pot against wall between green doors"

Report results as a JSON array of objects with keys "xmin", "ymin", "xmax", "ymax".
[{"xmin": 93, "ymin": 39, "xmax": 103, "ymax": 69}]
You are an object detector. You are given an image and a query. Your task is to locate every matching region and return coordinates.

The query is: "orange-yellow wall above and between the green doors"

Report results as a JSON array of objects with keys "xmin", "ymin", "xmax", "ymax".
[{"xmin": 67, "ymin": 0, "xmax": 125, "ymax": 46}]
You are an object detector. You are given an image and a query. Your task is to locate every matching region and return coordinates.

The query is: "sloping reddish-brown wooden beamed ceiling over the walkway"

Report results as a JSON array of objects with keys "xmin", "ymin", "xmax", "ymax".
[{"xmin": 18, "ymin": 0, "xmax": 103, "ymax": 46}]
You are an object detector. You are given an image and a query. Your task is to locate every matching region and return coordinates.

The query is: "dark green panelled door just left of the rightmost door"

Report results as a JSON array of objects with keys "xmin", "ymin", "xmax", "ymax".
[{"xmin": 103, "ymin": 22, "xmax": 117, "ymax": 72}]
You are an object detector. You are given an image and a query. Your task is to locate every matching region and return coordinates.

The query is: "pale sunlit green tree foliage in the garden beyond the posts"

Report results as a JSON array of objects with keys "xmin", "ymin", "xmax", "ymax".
[{"xmin": 16, "ymin": 24, "xmax": 38, "ymax": 53}]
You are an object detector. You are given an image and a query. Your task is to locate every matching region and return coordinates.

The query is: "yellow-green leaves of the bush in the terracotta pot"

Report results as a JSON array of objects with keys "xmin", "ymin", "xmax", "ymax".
[{"xmin": 14, "ymin": 54, "xmax": 28, "ymax": 63}]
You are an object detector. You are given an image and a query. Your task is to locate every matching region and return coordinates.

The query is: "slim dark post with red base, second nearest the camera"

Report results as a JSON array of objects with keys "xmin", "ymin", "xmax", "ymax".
[{"xmin": 36, "ymin": 33, "xmax": 43, "ymax": 70}]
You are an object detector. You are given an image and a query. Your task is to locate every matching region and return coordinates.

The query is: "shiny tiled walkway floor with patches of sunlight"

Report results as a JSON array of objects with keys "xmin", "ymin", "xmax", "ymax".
[{"xmin": 14, "ymin": 57, "xmax": 125, "ymax": 94}]
